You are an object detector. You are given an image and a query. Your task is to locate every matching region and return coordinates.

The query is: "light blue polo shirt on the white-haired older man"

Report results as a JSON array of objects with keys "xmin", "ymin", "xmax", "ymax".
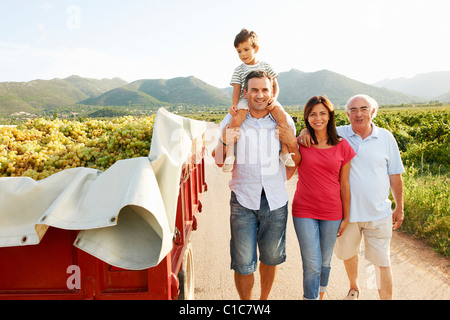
[{"xmin": 337, "ymin": 123, "xmax": 405, "ymax": 222}]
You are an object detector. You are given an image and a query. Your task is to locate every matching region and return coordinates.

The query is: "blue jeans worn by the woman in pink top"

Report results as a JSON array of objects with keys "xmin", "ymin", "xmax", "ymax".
[{"xmin": 293, "ymin": 217, "xmax": 341, "ymax": 300}]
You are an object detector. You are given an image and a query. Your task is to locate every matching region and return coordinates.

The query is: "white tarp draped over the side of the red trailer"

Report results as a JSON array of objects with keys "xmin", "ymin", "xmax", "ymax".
[{"xmin": 0, "ymin": 109, "xmax": 206, "ymax": 270}]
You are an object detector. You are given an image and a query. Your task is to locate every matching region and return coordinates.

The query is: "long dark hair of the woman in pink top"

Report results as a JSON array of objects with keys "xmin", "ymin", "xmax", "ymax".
[{"xmin": 303, "ymin": 96, "xmax": 341, "ymax": 146}]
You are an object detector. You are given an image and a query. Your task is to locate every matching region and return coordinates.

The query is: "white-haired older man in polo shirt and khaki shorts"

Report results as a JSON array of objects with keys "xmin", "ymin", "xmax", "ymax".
[{"xmin": 300, "ymin": 95, "xmax": 404, "ymax": 300}]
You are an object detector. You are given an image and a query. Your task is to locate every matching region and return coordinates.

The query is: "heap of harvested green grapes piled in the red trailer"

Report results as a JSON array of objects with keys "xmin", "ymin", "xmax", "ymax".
[{"xmin": 0, "ymin": 115, "xmax": 155, "ymax": 180}]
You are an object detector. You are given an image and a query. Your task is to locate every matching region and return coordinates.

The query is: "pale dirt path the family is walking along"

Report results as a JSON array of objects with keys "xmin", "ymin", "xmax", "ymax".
[{"xmin": 191, "ymin": 123, "xmax": 450, "ymax": 300}]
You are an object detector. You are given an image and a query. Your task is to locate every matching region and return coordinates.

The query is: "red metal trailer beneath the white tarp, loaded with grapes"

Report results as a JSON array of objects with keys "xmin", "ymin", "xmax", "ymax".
[{"xmin": 0, "ymin": 131, "xmax": 207, "ymax": 300}]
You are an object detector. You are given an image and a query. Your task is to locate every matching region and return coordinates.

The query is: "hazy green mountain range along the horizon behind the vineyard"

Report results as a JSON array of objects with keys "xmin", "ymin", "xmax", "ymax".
[{"xmin": 0, "ymin": 69, "xmax": 450, "ymax": 114}]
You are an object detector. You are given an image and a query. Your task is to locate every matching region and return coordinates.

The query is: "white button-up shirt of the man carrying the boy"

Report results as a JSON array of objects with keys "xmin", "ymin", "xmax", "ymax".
[{"xmin": 220, "ymin": 112, "xmax": 295, "ymax": 211}]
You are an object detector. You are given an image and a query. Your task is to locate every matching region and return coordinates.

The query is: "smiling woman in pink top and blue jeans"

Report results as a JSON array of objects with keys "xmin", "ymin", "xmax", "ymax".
[{"xmin": 292, "ymin": 96, "xmax": 355, "ymax": 299}]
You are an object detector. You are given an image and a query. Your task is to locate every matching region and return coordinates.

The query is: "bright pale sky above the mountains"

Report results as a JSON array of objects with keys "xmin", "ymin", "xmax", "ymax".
[{"xmin": 0, "ymin": 0, "xmax": 450, "ymax": 87}]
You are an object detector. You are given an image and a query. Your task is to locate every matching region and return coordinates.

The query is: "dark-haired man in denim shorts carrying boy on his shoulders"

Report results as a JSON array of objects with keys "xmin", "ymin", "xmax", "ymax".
[{"xmin": 214, "ymin": 71, "xmax": 300, "ymax": 300}]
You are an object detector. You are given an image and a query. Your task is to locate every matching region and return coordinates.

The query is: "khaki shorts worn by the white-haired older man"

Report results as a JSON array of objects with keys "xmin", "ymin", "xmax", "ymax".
[{"xmin": 336, "ymin": 215, "xmax": 392, "ymax": 267}]
